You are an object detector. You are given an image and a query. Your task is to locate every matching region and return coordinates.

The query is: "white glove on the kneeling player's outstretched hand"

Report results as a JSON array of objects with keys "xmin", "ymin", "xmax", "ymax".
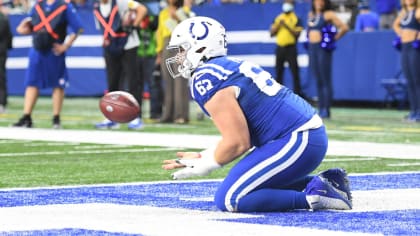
[{"xmin": 172, "ymin": 156, "xmax": 222, "ymax": 179}]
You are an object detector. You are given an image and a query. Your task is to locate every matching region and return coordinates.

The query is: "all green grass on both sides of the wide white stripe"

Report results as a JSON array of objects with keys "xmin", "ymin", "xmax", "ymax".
[{"xmin": 0, "ymin": 97, "xmax": 420, "ymax": 188}]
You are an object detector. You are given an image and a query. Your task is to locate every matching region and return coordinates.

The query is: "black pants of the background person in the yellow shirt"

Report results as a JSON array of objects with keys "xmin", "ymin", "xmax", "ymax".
[{"xmin": 276, "ymin": 45, "xmax": 302, "ymax": 95}]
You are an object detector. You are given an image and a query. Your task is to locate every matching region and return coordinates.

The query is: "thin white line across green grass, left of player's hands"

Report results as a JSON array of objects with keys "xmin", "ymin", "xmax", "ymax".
[{"xmin": 0, "ymin": 147, "xmax": 176, "ymax": 157}]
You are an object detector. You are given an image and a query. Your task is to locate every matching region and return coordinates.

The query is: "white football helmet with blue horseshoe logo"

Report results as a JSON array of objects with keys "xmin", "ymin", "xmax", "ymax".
[{"xmin": 166, "ymin": 16, "xmax": 227, "ymax": 79}]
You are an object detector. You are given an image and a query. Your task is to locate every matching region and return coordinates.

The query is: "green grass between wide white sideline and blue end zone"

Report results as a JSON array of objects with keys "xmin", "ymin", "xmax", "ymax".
[{"xmin": 0, "ymin": 140, "xmax": 420, "ymax": 188}]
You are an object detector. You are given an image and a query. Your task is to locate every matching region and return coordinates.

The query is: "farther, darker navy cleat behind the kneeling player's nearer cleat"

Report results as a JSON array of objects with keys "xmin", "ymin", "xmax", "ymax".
[{"xmin": 318, "ymin": 168, "xmax": 352, "ymax": 202}]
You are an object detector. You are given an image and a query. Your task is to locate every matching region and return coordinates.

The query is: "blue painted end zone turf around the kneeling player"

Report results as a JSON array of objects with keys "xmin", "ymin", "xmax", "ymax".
[{"xmin": 0, "ymin": 173, "xmax": 420, "ymax": 235}]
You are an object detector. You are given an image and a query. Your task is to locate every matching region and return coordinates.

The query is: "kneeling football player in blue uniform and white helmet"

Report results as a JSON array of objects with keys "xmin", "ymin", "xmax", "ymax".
[{"xmin": 162, "ymin": 17, "xmax": 352, "ymax": 212}]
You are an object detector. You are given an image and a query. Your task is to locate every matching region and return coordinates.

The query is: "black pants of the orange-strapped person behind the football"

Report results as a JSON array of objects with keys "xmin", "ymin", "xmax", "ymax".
[{"xmin": 104, "ymin": 47, "xmax": 143, "ymax": 117}]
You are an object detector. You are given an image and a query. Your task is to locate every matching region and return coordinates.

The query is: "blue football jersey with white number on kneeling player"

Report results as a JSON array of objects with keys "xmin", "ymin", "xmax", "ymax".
[{"xmin": 190, "ymin": 57, "xmax": 316, "ymax": 146}]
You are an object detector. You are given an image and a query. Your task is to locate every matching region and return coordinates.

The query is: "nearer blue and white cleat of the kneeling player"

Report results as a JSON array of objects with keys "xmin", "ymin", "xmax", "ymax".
[{"xmin": 305, "ymin": 176, "xmax": 352, "ymax": 210}]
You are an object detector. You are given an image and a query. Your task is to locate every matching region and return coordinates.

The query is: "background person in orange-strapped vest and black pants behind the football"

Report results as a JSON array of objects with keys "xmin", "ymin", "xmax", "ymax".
[{"xmin": 93, "ymin": 0, "xmax": 147, "ymax": 129}]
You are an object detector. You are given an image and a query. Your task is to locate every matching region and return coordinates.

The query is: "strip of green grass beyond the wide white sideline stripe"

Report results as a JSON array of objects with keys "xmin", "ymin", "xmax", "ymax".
[{"xmin": 0, "ymin": 97, "xmax": 420, "ymax": 144}]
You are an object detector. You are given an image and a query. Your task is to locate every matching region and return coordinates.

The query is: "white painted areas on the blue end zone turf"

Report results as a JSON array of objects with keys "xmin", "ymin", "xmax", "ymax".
[{"xmin": 0, "ymin": 189, "xmax": 420, "ymax": 236}]
